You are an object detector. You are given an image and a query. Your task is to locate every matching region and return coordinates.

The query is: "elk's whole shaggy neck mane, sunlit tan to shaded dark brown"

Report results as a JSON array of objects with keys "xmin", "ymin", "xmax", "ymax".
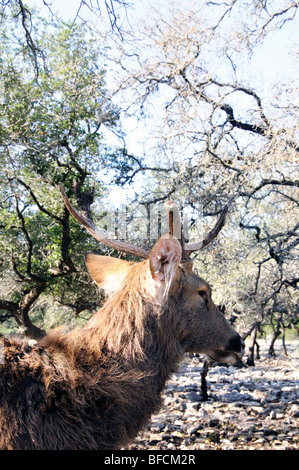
[{"xmin": 40, "ymin": 261, "xmax": 183, "ymax": 399}]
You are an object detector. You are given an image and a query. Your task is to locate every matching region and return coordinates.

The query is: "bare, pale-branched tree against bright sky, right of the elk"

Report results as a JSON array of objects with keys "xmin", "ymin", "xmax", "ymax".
[{"xmin": 104, "ymin": 1, "xmax": 299, "ymax": 352}]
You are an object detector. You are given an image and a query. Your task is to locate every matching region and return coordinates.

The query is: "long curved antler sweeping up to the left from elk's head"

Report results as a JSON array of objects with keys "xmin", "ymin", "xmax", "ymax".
[{"xmin": 59, "ymin": 183, "xmax": 150, "ymax": 259}]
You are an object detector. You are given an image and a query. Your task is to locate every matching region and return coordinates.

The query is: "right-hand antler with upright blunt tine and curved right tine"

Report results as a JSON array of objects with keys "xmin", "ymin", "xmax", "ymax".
[{"xmin": 165, "ymin": 200, "xmax": 228, "ymax": 260}]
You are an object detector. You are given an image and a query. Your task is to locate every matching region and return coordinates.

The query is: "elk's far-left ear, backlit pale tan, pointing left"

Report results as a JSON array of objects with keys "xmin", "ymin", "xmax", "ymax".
[{"xmin": 85, "ymin": 253, "xmax": 135, "ymax": 293}]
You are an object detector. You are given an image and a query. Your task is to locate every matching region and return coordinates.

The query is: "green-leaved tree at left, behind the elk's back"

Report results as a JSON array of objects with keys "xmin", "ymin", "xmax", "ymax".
[{"xmin": 0, "ymin": 11, "xmax": 122, "ymax": 339}]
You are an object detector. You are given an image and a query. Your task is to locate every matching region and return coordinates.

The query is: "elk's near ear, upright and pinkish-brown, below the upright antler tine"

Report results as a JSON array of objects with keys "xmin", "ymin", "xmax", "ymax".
[{"xmin": 149, "ymin": 237, "xmax": 182, "ymax": 282}]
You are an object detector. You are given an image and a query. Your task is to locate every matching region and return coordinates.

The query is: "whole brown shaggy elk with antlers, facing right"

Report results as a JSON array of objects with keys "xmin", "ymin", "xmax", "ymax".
[{"xmin": 0, "ymin": 186, "xmax": 243, "ymax": 450}]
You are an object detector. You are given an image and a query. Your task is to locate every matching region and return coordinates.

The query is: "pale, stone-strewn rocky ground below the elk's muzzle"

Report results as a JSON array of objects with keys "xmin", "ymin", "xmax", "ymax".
[{"xmin": 129, "ymin": 345, "xmax": 299, "ymax": 450}]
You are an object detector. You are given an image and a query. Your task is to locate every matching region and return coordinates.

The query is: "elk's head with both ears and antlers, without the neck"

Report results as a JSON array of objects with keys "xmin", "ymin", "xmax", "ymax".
[{"xmin": 60, "ymin": 185, "xmax": 244, "ymax": 363}]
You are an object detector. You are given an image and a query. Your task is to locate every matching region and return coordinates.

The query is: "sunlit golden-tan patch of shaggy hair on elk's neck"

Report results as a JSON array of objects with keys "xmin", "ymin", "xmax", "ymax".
[{"xmin": 81, "ymin": 261, "xmax": 161, "ymax": 360}]
